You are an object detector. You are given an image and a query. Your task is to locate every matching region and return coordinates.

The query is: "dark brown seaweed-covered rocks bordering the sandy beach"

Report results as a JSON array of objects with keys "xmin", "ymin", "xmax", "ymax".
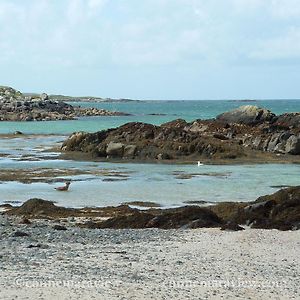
[{"xmin": 2, "ymin": 186, "xmax": 300, "ymax": 231}]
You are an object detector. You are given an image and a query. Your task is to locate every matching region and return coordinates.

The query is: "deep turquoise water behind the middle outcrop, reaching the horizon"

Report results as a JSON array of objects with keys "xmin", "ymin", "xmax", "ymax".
[{"xmin": 0, "ymin": 100, "xmax": 300, "ymax": 134}]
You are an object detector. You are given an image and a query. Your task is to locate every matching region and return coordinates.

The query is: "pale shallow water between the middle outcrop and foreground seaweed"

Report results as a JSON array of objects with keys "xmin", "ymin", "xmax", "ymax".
[{"xmin": 0, "ymin": 152, "xmax": 300, "ymax": 207}]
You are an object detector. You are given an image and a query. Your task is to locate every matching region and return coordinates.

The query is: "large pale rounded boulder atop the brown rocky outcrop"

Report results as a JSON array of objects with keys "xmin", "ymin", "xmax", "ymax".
[{"xmin": 217, "ymin": 105, "xmax": 275, "ymax": 125}]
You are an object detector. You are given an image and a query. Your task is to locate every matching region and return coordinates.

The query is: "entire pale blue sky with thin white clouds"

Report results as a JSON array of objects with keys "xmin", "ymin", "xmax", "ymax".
[{"xmin": 0, "ymin": 0, "xmax": 300, "ymax": 100}]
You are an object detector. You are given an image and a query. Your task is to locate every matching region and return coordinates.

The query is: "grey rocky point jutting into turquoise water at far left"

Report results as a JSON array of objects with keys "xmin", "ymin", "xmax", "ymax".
[{"xmin": 0, "ymin": 87, "xmax": 129, "ymax": 121}]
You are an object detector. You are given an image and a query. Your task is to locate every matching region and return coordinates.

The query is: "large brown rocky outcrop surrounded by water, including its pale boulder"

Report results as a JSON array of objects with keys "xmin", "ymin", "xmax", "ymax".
[{"xmin": 62, "ymin": 105, "xmax": 300, "ymax": 163}]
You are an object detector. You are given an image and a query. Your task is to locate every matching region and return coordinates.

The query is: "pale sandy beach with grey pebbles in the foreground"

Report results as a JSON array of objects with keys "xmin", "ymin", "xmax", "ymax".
[{"xmin": 0, "ymin": 215, "xmax": 300, "ymax": 299}]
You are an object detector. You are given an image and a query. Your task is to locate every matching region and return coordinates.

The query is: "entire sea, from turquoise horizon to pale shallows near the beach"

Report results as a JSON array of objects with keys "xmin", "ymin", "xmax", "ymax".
[{"xmin": 0, "ymin": 100, "xmax": 300, "ymax": 207}]
